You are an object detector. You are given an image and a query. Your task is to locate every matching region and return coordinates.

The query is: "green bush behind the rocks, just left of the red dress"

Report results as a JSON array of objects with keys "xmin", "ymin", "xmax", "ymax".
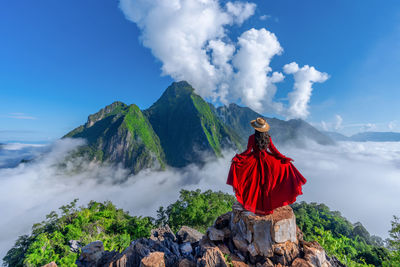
[{"xmin": 156, "ymin": 189, "xmax": 235, "ymax": 233}]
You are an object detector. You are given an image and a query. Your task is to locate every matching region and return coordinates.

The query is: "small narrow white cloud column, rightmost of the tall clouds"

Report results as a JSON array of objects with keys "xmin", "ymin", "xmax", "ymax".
[{"xmin": 283, "ymin": 62, "xmax": 329, "ymax": 119}]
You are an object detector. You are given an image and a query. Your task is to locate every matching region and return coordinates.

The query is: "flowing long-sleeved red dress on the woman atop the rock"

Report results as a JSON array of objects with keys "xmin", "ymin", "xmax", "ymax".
[{"xmin": 226, "ymin": 134, "xmax": 307, "ymax": 215}]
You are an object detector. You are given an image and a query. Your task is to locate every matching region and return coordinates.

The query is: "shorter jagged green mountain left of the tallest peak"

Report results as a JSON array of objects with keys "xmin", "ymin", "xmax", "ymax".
[{"xmin": 63, "ymin": 102, "xmax": 165, "ymax": 173}]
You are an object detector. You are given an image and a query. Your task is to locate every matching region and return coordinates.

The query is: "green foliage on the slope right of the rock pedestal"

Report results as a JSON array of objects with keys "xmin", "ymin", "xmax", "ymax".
[{"xmin": 292, "ymin": 202, "xmax": 390, "ymax": 266}]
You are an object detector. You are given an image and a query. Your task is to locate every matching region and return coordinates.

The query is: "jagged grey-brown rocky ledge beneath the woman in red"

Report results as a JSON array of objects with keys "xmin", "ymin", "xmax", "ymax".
[{"xmin": 44, "ymin": 203, "xmax": 345, "ymax": 267}]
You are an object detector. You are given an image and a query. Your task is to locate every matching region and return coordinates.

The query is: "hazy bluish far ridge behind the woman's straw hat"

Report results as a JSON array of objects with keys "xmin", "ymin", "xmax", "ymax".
[{"xmin": 210, "ymin": 104, "xmax": 334, "ymax": 145}]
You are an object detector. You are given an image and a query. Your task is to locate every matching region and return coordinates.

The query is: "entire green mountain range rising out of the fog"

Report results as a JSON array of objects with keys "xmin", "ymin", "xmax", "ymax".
[{"xmin": 64, "ymin": 81, "xmax": 334, "ymax": 173}]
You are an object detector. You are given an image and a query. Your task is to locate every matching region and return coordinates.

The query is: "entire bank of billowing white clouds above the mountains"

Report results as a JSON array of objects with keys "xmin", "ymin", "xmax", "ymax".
[{"xmin": 120, "ymin": 0, "xmax": 325, "ymax": 118}]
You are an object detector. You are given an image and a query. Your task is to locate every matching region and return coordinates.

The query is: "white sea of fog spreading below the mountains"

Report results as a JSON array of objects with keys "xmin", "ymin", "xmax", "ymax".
[{"xmin": 0, "ymin": 139, "xmax": 400, "ymax": 262}]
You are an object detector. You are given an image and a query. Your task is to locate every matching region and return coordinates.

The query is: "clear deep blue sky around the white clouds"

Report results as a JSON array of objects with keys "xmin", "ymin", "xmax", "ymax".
[{"xmin": 0, "ymin": 0, "xmax": 400, "ymax": 142}]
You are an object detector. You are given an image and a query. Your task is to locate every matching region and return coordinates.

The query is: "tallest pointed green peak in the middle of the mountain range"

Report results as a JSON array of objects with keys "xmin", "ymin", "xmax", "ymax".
[{"xmin": 143, "ymin": 81, "xmax": 242, "ymax": 167}]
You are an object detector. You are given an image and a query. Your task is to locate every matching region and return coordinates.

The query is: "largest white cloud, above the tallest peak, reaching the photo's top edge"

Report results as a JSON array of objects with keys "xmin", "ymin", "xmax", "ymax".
[{"xmin": 120, "ymin": 0, "xmax": 255, "ymax": 97}]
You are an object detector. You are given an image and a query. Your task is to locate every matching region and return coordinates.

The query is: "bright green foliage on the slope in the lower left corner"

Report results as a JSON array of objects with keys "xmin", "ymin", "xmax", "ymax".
[{"xmin": 3, "ymin": 200, "xmax": 154, "ymax": 266}]
